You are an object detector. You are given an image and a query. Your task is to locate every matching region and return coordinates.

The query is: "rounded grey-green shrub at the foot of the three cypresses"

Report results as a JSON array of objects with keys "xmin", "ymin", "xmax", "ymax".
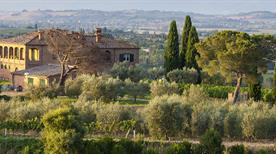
[{"xmin": 167, "ymin": 69, "xmax": 198, "ymax": 84}]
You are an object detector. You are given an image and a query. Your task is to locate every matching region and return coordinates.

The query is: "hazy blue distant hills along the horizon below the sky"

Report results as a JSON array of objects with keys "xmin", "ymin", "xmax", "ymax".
[{"xmin": 0, "ymin": 10, "xmax": 276, "ymax": 33}]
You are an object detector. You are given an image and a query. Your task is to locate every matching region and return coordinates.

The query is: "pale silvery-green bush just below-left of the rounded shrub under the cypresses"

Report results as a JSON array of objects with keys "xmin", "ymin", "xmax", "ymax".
[{"xmin": 150, "ymin": 79, "xmax": 180, "ymax": 97}]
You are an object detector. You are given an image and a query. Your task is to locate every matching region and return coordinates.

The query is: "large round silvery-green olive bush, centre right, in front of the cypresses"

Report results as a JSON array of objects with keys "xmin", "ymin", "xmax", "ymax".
[{"xmin": 144, "ymin": 96, "xmax": 192, "ymax": 138}]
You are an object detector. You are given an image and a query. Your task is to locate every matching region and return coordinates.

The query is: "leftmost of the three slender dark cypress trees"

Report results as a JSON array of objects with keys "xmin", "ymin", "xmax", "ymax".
[{"xmin": 164, "ymin": 20, "xmax": 179, "ymax": 72}]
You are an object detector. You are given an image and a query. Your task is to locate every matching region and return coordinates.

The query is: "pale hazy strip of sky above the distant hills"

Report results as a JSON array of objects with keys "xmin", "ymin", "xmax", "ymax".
[{"xmin": 0, "ymin": 0, "xmax": 276, "ymax": 14}]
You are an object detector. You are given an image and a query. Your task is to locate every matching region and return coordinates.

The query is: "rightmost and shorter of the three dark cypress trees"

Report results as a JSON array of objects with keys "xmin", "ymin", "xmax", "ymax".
[{"xmin": 185, "ymin": 26, "xmax": 201, "ymax": 84}]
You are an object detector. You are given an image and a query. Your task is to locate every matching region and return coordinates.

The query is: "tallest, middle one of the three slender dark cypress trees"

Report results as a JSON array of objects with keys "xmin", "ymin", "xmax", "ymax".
[{"xmin": 179, "ymin": 16, "xmax": 192, "ymax": 69}]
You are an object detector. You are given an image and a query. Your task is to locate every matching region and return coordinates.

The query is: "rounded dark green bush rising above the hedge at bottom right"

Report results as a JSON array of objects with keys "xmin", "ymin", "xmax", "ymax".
[{"xmin": 200, "ymin": 129, "xmax": 224, "ymax": 154}]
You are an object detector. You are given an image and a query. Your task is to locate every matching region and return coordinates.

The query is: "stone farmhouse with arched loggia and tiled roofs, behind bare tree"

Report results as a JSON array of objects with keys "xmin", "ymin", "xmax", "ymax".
[{"xmin": 0, "ymin": 28, "xmax": 139, "ymax": 87}]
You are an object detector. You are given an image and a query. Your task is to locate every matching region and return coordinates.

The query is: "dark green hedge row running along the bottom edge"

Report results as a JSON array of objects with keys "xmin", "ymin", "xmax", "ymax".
[{"xmin": 0, "ymin": 136, "xmax": 275, "ymax": 154}]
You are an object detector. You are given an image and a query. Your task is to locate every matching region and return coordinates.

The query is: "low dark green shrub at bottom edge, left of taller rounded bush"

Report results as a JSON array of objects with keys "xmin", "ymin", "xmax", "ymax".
[{"xmin": 166, "ymin": 142, "xmax": 192, "ymax": 154}]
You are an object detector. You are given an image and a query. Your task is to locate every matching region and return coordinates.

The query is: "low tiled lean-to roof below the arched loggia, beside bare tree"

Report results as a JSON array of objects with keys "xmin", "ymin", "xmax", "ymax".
[{"xmin": 13, "ymin": 64, "xmax": 61, "ymax": 77}]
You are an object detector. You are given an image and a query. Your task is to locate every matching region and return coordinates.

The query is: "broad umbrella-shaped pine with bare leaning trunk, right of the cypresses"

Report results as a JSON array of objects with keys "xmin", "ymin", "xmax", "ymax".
[{"xmin": 196, "ymin": 31, "xmax": 268, "ymax": 103}]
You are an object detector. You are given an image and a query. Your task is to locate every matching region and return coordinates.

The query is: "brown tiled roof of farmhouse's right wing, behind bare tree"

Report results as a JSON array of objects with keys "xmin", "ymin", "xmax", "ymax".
[{"xmin": 87, "ymin": 36, "xmax": 139, "ymax": 49}]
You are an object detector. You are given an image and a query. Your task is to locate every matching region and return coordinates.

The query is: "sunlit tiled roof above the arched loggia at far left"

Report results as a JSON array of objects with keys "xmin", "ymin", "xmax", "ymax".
[{"xmin": 0, "ymin": 32, "xmax": 39, "ymax": 44}]
